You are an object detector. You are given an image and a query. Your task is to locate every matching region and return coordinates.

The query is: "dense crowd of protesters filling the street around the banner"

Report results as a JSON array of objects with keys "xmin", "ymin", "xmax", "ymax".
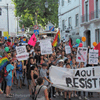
[{"xmin": 0, "ymin": 37, "xmax": 100, "ymax": 100}]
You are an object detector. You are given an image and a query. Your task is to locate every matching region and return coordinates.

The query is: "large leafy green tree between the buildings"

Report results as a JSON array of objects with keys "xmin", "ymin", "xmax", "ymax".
[{"xmin": 13, "ymin": 0, "xmax": 58, "ymax": 27}]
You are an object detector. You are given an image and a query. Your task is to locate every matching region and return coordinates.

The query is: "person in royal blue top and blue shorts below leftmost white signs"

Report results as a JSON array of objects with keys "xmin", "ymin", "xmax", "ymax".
[{"xmin": 15, "ymin": 61, "xmax": 23, "ymax": 89}]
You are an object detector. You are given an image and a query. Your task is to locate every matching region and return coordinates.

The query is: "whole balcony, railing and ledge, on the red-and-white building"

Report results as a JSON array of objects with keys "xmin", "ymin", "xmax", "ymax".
[{"xmin": 81, "ymin": 10, "xmax": 100, "ymax": 25}]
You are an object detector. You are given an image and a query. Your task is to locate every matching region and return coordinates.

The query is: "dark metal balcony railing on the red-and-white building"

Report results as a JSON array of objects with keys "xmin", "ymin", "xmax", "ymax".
[{"xmin": 81, "ymin": 10, "xmax": 100, "ymax": 23}]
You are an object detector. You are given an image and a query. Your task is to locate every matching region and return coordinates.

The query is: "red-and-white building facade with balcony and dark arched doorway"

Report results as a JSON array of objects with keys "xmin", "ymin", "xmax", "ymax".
[{"xmin": 80, "ymin": 0, "xmax": 100, "ymax": 47}]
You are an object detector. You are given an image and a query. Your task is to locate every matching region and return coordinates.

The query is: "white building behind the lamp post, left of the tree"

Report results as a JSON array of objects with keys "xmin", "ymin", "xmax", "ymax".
[{"xmin": 0, "ymin": 0, "xmax": 17, "ymax": 36}]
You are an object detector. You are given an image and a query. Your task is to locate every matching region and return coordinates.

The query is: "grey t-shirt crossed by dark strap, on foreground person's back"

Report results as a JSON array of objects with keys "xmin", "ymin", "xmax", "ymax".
[{"xmin": 36, "ymin": 85, "xmax": 47, "ymax": 100}]
